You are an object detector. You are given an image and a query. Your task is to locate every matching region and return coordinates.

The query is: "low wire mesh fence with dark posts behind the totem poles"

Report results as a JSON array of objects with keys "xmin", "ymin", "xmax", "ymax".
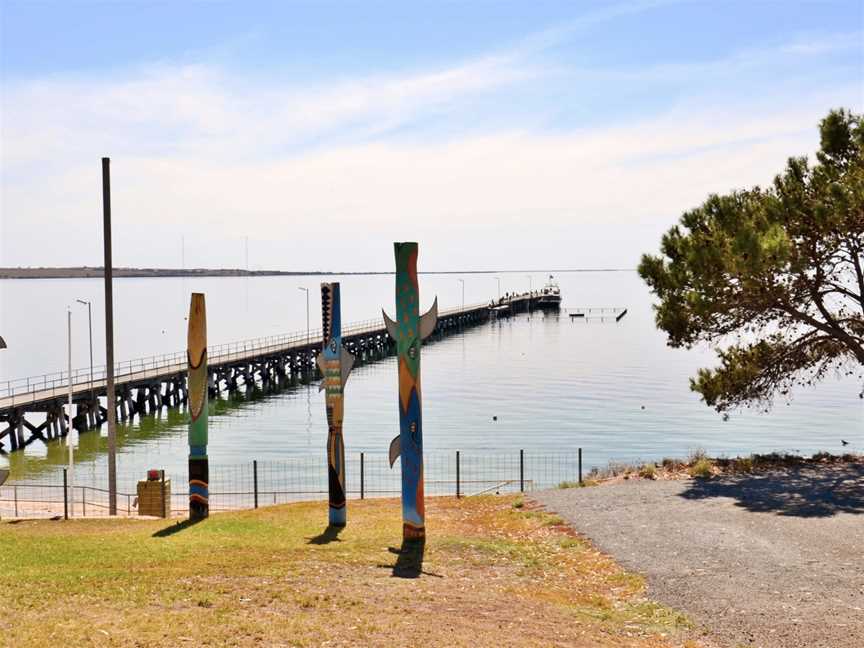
[{"xmin": 0, "ymin": 448, "xmax": 582, "ymax": 518}]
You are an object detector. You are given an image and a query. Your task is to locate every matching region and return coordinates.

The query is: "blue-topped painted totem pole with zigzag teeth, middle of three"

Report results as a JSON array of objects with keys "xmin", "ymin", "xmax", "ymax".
[{"xmin": 317, "ymin": 283, "xmax": 354, "ymax": 527}]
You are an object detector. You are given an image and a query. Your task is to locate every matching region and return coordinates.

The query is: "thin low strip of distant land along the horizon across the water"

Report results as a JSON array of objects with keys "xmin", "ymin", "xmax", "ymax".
[{"xmin": 0, "ymin": 266, "xmax": 633, "ymax": 279}]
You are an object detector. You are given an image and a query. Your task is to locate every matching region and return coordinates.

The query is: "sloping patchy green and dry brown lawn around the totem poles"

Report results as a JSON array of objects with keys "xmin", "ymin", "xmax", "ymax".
[{"xmin": 0, "ymin": 497, "xmax": 697, "ymax": 647}]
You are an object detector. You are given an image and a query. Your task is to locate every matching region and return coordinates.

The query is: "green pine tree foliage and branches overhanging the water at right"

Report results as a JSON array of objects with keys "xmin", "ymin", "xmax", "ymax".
[{"xmin": 639, "ymin": 109, "xmax": 864, "ymax": 411}]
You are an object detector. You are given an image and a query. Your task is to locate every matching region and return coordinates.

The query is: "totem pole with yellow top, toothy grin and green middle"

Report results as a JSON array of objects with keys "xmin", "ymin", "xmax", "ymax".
[{"xmin": 186, "ymin": 293, "xmax": 210, "ymax": 520}]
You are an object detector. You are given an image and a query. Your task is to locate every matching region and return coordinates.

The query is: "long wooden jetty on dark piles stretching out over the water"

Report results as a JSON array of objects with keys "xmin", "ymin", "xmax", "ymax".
[{"xmin": 0, "ymin": 292, "xmax": 552, "ymax": 453}]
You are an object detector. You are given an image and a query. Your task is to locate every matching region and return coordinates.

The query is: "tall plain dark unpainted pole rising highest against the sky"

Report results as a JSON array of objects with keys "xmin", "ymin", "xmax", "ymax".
[{"xmin": 102, "ymin": 158, "xmax": 117, "ymax": 515}]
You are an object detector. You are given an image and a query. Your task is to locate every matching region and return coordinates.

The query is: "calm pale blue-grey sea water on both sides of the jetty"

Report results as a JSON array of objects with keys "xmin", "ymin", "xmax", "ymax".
[{"xmin": 0, "ymin": 270, "xmax": 864, "ymax": 485}]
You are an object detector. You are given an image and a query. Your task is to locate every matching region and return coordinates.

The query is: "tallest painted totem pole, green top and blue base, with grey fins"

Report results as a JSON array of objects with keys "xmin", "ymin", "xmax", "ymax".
[{"xmin": 384, "ymin": 243, "xmax": 438, "ymax": 540}]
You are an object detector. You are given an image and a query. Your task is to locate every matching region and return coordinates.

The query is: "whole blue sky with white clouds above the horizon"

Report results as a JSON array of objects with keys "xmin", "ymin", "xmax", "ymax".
[{"xmin": 0, "ymin": 0, "xmax": 864, "ymax": 271}]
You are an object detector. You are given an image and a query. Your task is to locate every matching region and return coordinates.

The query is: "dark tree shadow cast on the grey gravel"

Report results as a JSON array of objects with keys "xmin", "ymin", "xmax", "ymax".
[{"xmin": 681, "ymin": 463, "xmax": 864, "ymax": 518}]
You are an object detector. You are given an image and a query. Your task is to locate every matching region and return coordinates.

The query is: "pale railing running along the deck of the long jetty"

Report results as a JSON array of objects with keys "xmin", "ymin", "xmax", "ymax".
[{"xmin": 0, "ymin": 302, "xmax": 488, "ymax": 406}]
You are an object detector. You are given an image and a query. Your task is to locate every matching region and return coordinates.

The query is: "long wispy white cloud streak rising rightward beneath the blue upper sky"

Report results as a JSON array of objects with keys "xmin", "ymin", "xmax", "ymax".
[{"xmin": 2, "ymin": 52, "xmax": 542, "ymax": 171}]
